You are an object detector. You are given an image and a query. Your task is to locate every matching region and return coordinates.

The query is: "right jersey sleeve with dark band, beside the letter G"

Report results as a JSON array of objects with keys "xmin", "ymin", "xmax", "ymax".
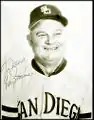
[{"xmin": 79, "ymin": 76, "xmax": 92, "ymax": 119}]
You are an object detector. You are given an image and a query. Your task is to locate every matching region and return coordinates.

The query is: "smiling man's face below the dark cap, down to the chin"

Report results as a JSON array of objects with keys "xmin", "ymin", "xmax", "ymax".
[{"xmin": 29, "ymin": 19, "xmax": 64, "ymax": 64}]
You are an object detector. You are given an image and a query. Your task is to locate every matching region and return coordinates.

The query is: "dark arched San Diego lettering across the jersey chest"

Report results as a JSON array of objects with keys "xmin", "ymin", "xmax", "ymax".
[{"xmin": 18, "ymin": 92, "xmax": 80, "ymax": 119}]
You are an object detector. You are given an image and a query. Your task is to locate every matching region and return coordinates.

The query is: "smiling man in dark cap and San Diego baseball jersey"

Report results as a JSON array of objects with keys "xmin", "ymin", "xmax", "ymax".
[{"xmin": 2, "ymin": 4, "xmax": 91, "ymax": 119}]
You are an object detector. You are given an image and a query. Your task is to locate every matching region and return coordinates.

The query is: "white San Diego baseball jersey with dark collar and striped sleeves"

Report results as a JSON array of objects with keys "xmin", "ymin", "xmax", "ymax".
[{"xmin": 1, "ymin": 57, "xmax": 92, "ymax": 120}]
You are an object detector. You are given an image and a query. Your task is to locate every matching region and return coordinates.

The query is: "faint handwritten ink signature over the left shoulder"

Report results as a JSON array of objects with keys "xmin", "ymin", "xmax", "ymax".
[{"xmin": 1, "ymin": 58, "xmax": 33, "ymax": 89}]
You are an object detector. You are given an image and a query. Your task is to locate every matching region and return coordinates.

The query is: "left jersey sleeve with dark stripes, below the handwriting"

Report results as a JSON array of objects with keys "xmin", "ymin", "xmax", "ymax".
[{"xmin": 1, "ymin": 56, "xmax": 18, "ymax": 120}]
